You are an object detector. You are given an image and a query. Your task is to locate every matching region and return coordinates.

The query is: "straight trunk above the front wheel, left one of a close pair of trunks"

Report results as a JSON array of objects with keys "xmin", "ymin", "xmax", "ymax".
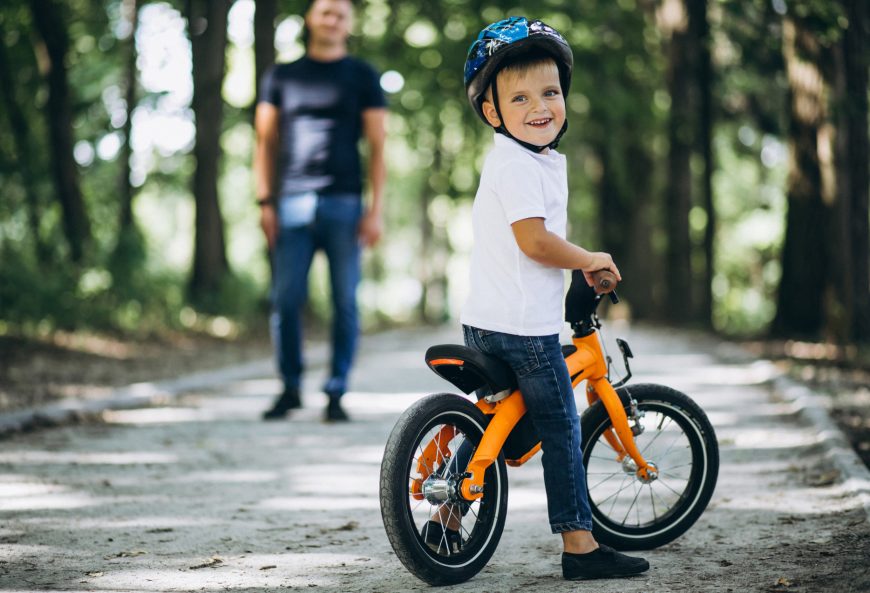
[{"xmin": 665, "ymin": 0, "xmax": 698, "ymax": 323}]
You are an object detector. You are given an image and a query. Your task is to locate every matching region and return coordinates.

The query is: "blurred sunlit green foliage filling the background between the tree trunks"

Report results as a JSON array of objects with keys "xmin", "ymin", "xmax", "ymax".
[{"xmin": 0, "ymin": 0, "xmax": 864, "ymax": 334}]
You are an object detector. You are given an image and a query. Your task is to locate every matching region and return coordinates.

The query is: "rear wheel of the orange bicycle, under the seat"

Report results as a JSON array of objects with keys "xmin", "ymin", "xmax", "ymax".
[{"xmin": 380, "ymin": 393, "xmax": 508, "ymax": 585}]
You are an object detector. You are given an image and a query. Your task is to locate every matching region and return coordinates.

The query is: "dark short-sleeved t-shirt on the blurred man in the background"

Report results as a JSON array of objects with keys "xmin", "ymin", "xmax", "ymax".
[{"xmin": 260, "ymin": 56, "xmax": 386, "ymax": 195}]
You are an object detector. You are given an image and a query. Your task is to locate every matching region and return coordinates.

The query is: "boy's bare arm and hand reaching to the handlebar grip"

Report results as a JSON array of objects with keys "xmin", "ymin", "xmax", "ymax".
[{"xmin": 511, "ymin": 218, "xmax": 622, "ymax": 286}]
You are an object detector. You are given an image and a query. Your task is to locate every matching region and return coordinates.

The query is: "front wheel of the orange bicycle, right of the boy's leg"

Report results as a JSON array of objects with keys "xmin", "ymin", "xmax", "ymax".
[{"xmin": 582, "ymin": 384, "xmax": 719, "ymax": 550}]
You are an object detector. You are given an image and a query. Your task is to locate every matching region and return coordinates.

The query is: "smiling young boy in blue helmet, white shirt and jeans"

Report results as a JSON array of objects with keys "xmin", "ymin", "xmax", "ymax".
[{"xmin": 461, "ymin": 17, "xmax": 649, "ymax": 580}]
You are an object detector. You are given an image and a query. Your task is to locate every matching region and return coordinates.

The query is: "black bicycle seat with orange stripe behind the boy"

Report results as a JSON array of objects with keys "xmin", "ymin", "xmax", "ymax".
[{"xmin": 426, "ymin": 344, "xmax": 517, "ymax": 401}]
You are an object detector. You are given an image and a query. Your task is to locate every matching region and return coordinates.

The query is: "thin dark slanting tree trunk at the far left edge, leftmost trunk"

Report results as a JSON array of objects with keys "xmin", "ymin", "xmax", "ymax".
[{"xmin": 0, "ymin": 23, "xmax": 49, "ymax": 263}]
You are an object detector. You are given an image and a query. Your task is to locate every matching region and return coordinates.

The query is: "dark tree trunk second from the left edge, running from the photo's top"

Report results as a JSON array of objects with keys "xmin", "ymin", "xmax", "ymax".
[{"xmin": 30, "ymin": 0, "xmax": 91, "ymax": 262}]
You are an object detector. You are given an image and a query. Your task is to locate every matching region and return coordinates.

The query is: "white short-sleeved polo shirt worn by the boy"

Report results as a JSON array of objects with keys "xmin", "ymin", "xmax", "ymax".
[{"xmin": 460, "ymin": 134, "xmax": 568, "ymax": 336}]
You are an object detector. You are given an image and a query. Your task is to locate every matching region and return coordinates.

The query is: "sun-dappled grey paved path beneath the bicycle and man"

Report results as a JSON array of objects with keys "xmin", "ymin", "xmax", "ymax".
[{"xmin": 0, "ymin": 328, "xmax": 870, "ymax": 593}]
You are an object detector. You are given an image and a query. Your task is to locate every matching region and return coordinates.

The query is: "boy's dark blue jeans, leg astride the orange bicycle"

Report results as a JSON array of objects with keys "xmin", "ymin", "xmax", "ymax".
[{"xmin": 462, "ymin": 325, "xmax": 592, "ymax": 533}]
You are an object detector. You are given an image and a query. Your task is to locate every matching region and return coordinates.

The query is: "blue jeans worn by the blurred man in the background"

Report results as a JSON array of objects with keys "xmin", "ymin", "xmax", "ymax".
[{"xmin": 271, "ymin": 193, "xmax": 362, "ymax": 398}]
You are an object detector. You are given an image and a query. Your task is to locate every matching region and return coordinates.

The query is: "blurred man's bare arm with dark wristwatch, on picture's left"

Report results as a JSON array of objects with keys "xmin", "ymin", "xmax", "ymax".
[{"xmin": 254, "ymin": 102, "xmax": 281, "ymax": 250}]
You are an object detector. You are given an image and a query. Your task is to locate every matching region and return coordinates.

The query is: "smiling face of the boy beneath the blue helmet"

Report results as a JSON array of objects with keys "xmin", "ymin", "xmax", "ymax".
[{"xmin": 482, "ymin": 60, "xmax": 565, "ymax": 146}]
